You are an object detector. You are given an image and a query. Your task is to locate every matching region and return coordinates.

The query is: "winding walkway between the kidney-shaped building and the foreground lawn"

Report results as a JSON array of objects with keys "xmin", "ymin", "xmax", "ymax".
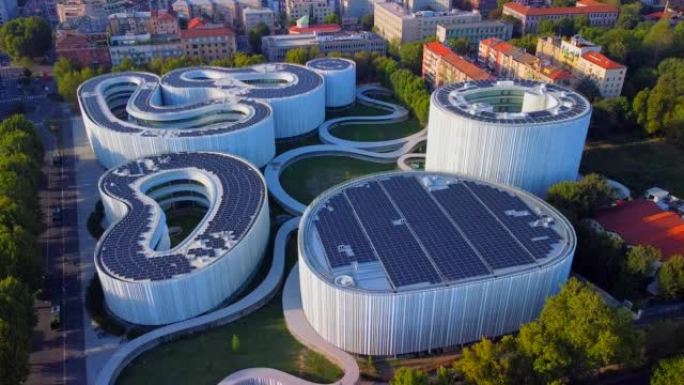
[{"xmin": 95, "ymin": 217, "xmax": 300, "ymax": 385}]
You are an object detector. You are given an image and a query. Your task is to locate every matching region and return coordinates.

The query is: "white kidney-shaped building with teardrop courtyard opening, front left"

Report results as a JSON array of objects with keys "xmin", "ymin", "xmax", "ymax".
[{"xmin": 95, "ymin": 153, "xmax": 269, "ymax": 325}]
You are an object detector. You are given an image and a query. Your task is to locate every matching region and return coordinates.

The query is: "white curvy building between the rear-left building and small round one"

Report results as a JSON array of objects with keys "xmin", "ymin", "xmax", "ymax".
[{"xmin": 161, "ymin": 63, "xmax": 325, "ymax": 138}]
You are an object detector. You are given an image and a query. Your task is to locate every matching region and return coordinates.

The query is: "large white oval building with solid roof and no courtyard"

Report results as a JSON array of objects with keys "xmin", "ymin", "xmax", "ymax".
[{"xmin": 299, "ymin": 172, "xmax": 576, "ymax": 355}]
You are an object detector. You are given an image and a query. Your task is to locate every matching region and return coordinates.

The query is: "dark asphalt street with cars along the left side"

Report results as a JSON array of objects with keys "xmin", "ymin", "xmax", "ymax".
[{"xmin": 26, "ymin": 102, "xmax": 86, "ymax": 385}]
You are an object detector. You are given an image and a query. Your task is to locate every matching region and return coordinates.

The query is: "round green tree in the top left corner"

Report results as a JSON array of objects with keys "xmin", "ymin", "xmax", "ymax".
[{"xmin": 0, "ymin": 16, "xmax": 52, "ymax": 62}]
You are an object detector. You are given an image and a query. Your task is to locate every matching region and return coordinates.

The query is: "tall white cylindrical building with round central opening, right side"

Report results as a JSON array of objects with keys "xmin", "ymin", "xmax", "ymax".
[{"xmin": 425, "ymin": 80, "xmax": 591, "ymax": 196}]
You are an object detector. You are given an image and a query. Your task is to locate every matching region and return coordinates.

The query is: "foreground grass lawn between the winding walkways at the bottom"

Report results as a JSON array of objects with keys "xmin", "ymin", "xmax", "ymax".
[{"xmin": 117, "ymin": 237, "xmax": 343, "ymax": 385}]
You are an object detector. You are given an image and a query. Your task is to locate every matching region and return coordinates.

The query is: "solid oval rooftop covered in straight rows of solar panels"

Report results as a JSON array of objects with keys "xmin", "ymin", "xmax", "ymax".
[{"xmin": 299, "ymin": 172, "xmax": 575, "ymax": 291}]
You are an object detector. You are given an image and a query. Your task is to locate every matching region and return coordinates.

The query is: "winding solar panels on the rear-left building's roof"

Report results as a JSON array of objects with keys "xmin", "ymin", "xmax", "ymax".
[{"xmin": 79, "ymin": 72, "xmax": 271, "ymax": 137}]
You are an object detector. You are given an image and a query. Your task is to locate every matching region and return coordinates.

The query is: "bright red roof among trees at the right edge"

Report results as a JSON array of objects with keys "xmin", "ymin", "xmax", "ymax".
[{"xmin": 596, "ymin": 199, "xmax": 684, "ymax": 260}]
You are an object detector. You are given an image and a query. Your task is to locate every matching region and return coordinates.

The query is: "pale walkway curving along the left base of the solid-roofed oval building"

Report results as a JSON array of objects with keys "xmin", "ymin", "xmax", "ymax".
[{"xmin": 218, "ymin": 265, "xmax": 360, "ymax": 385}]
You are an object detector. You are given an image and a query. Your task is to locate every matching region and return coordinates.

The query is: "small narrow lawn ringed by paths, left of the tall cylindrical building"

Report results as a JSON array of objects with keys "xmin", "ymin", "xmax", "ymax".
[{"xmin": 331, "ymin": 118, "xmax": 421, "ymax": 142}]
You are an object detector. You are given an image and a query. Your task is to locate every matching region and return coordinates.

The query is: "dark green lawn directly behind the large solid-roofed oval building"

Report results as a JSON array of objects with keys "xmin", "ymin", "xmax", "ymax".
[{"xmin": 280, "ymin": 156, "xmax": 396, "ymax": 204}]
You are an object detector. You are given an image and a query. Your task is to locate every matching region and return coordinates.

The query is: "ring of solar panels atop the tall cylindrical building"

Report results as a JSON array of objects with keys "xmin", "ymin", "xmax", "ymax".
[{"xmin": 434, "ymin": 79, "xmax": 589, "ymax": 124}]
